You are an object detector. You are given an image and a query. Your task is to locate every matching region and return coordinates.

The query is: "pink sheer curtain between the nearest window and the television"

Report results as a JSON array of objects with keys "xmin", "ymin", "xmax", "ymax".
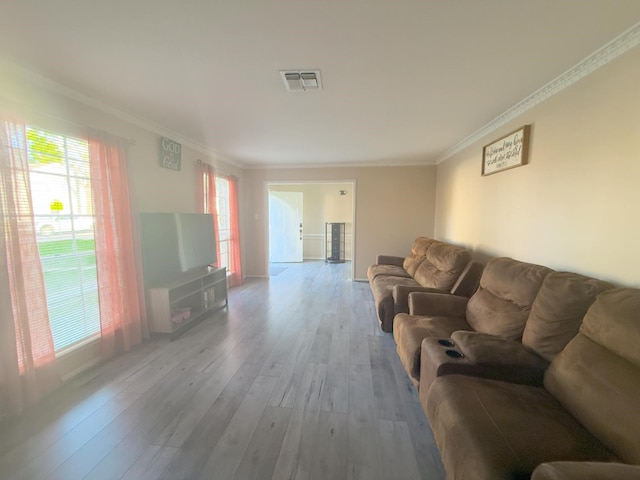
[{"xmin": 89, "ymin": 133, "xmax": 148, "ymax": 358}]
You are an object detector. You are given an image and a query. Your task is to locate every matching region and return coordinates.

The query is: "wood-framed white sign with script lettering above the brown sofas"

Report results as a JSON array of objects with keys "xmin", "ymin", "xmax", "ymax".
[{"xmin": 482, "ymin": 125, "xmax": 531, "ymax": 175}]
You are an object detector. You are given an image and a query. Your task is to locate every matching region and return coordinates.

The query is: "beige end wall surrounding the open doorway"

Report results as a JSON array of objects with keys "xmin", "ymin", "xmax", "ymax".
[{"xmin": 244, "ymin": 166, "xmax": 436, "ymax": 279}]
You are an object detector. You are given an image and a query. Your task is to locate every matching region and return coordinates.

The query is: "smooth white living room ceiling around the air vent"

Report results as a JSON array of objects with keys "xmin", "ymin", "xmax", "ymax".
[{"xmin": 0, "ymin": 0, "xmax": 640, "ymax": 167}]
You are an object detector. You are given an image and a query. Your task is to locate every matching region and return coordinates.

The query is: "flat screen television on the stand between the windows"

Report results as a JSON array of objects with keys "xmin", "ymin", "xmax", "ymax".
[{"xmin": 140, "ymin": 213, "xmax": 217, "ymax": 286}]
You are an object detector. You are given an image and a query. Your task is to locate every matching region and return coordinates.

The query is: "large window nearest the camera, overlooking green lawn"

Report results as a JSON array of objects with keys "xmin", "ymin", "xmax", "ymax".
[{"xmin": 27, "ymin": 127, "xmax": 100, "ymax": 352}]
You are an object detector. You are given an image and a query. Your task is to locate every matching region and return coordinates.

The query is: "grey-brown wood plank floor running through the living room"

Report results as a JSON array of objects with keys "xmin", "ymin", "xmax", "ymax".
[{"xmin": 0, "ymin": 262, "xmax": 444, "ymax": 480}]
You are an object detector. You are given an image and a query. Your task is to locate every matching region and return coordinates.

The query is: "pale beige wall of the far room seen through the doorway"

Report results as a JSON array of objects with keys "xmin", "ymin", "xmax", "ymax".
[{"xmin": 268, "ymin": 183, "xmax": 353, "ymax": 260}]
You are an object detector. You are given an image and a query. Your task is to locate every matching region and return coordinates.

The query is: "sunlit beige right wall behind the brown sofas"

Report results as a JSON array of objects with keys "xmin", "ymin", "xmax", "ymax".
[{"xmin": 435, "ymin": 48, "xmax": 640, "ymax": 287}]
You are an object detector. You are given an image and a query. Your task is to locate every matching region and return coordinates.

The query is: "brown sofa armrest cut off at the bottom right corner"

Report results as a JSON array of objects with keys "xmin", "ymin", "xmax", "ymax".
[{"xmin": 531, "ymin": 462, "xmax": 640, "ymax": 480}]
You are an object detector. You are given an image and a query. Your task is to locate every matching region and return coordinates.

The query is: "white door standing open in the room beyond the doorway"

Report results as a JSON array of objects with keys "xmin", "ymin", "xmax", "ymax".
[{"xmin": 269, "ymin": 191, "xmax": 302, "ymax": 263}]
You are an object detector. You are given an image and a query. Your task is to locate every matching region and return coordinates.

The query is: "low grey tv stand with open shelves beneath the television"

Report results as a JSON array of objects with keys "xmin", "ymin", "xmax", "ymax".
[{"xmin": 148, "ymin": 267, "xmax": 229, "ymax": 340}]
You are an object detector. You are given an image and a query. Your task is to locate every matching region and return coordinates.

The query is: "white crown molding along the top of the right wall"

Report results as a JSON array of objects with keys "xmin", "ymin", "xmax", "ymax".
[{"xmin": 434, "ymin": 22, "xmax": 640, "ymax": 165}]
